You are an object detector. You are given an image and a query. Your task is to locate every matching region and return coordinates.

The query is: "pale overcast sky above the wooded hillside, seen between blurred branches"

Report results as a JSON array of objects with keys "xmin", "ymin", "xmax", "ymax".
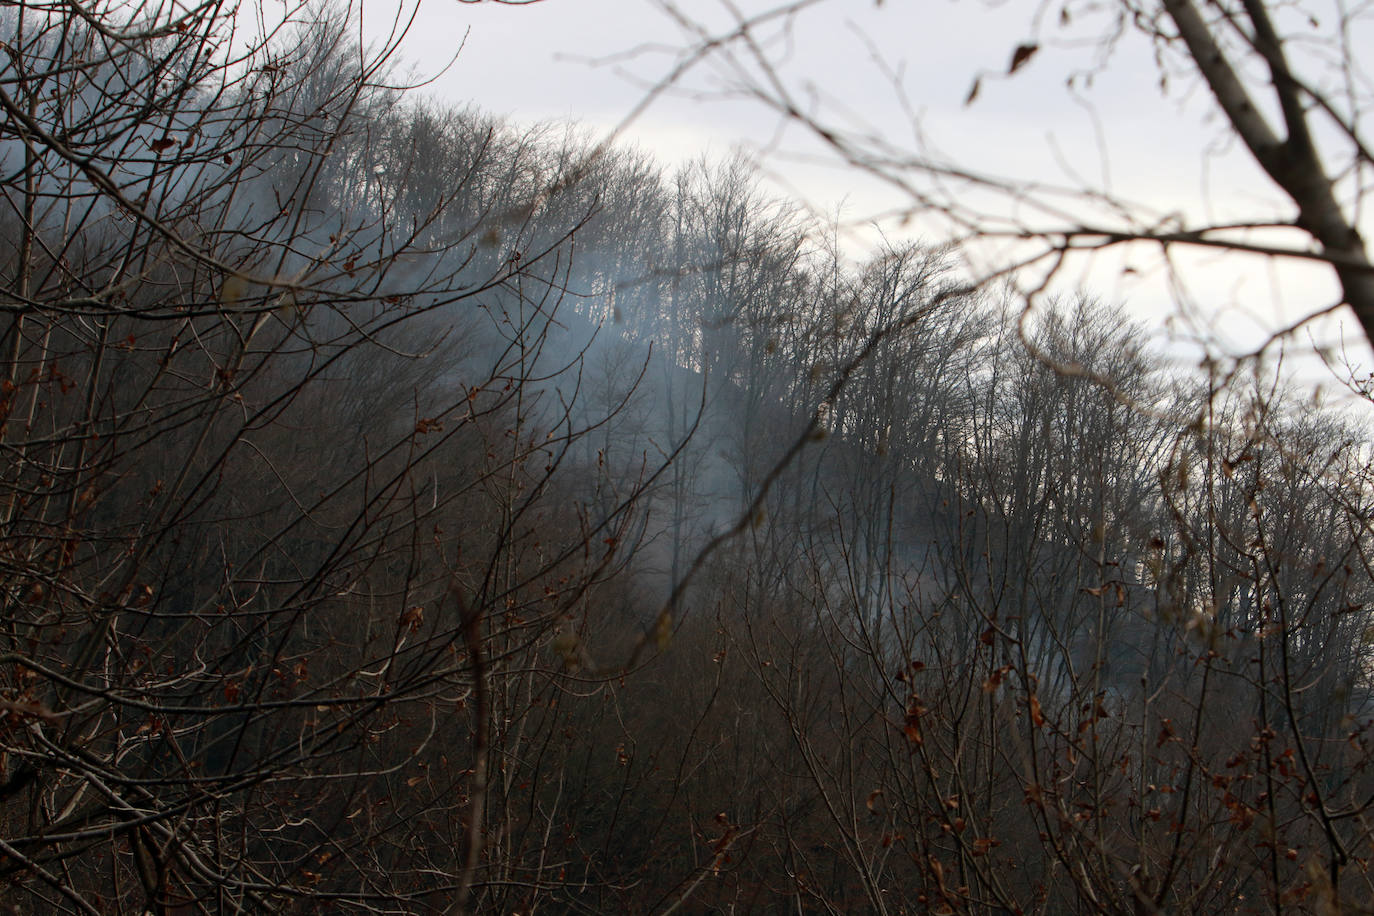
[{"xmin": 364, "ymin": 0, "xmax": 1369, "ymax": 381}]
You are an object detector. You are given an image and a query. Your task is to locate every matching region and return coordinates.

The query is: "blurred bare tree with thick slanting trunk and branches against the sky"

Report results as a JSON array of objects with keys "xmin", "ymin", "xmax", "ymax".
[{"xmin": 643, "ymin": 0, "xmax": 1374, "ymax": 370}]
